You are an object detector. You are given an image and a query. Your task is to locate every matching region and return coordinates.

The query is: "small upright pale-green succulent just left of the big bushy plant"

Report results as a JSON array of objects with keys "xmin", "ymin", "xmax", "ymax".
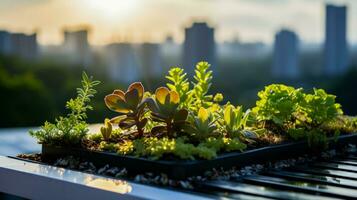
[{"xmin": 223, "ymin": 105, "xmax": 253, "ymax": 138}]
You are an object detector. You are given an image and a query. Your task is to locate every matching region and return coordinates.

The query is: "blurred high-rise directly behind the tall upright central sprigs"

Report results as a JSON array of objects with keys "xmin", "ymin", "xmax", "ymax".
[{"xmin": 183, "ymin": 22, "xmax": 216, "ymax": 73}]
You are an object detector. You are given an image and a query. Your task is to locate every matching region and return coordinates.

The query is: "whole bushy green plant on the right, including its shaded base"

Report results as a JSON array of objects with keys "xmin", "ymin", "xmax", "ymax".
[{"xmin": 253, "ymin": 84, "xmax": 343, "ymax": 147}]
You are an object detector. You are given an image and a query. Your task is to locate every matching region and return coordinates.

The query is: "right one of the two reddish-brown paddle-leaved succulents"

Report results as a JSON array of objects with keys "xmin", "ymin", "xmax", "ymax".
[{"xmin": 147, "ymin": 87, "xmax": 188, "ymax": 137}]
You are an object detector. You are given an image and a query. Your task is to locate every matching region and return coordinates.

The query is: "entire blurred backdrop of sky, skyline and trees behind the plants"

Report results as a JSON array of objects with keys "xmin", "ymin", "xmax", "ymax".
[{"xmin": 0, "ymin": 0, "xmax": 357, "ymax": 128}]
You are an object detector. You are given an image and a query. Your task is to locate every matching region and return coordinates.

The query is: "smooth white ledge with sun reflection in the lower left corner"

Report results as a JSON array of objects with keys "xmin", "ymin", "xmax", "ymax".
[{"xmin": 0, "ymin": 156, "xmax": 210, "ymax": 200}]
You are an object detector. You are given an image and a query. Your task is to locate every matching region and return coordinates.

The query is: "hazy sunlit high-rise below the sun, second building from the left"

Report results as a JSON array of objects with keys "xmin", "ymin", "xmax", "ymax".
[{"xmin": 62, "ymin": 29, "xmax": 92, "ymax": 67}]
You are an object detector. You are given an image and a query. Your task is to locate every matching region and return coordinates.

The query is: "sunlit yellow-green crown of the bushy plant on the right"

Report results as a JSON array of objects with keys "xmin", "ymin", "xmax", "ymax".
[{"xmin": 253, "ymin": 84, "xmax": 342, "ymax": 127}]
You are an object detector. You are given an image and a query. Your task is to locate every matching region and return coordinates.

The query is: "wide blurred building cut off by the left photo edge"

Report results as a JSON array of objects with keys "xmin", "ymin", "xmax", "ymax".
[{"xmin": 0, "ymin": 31, "xmax": 38, "ymax": 59}]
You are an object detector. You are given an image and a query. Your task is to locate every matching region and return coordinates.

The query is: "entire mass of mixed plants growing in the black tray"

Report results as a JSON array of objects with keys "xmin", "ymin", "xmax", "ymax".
[{"xmin": 27, "ymin": 62, "xmax": 350, "ymax": 159}]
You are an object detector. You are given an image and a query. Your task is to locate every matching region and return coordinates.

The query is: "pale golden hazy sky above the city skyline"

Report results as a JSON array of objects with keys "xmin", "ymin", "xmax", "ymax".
[{"xmin": 0, "ymin": 0, "xmax": 357, "ymax": 45}]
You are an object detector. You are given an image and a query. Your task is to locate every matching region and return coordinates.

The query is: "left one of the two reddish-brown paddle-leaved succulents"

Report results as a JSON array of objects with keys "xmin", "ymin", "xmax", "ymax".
[{"xmin": 104, "ymin": 82, "xmax": 148, "ymax": 137}]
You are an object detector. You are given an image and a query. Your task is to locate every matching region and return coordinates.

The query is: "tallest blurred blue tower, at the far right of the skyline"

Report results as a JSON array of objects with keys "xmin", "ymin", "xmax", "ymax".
[{"xmin": 324, "ymin": 5, "xmax": 348, "ymax": 76}]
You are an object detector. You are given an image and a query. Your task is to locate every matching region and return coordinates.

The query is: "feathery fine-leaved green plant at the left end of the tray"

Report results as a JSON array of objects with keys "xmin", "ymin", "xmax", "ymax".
[{"xmin": 30, "ymin": 72, "xmax": 100, "ymax": 145}]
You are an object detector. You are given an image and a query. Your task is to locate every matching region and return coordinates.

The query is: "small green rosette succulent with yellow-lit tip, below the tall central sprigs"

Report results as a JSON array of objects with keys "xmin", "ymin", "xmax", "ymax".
[{"xmin": 185, "ymin": 107, "xmax": 217, "ymax": 141}]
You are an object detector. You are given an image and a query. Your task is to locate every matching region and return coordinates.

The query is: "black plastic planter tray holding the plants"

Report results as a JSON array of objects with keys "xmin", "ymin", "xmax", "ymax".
[{"xmin": 42, "ymin": 134, "xmax": 357, "ymax": 179}]
